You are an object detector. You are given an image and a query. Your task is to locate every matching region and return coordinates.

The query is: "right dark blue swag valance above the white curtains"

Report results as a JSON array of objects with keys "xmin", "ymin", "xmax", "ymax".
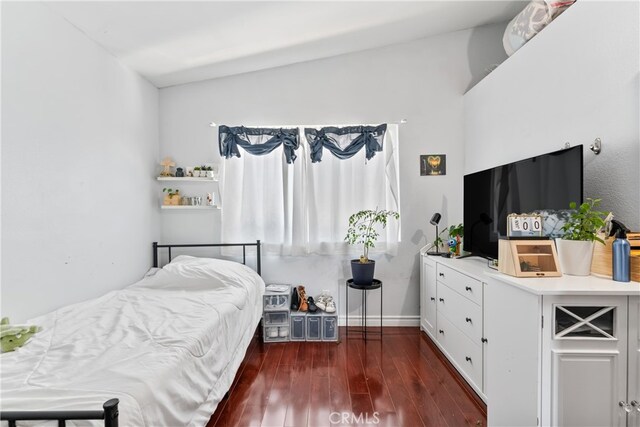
[{"xmin": 304, "ymin": 123, "xmax": 387, "ymax": 163}]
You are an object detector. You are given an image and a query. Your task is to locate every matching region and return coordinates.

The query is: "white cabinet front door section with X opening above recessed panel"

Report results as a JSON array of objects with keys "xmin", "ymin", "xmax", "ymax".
[{"xmin": 542, "ymin": 296, "xmax": 628, "ymax": 427}]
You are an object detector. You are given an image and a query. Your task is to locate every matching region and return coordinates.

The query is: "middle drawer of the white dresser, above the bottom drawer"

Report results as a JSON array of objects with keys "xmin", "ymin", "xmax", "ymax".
[{"xmin": 437, "ymin": 283, "xmax": 482, "ymax": 344}]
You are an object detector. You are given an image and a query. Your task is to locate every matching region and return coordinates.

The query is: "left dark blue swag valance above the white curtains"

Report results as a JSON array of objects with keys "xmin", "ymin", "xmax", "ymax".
[{"xmin": 218, "ymin": 125, "xmax": 300, "ymax": 163}]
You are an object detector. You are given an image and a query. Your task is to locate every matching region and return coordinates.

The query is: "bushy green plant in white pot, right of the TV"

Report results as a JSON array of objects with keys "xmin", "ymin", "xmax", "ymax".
[{"xmin": 556, "ymin": 198, "xmax": 607, "ymax": 276}]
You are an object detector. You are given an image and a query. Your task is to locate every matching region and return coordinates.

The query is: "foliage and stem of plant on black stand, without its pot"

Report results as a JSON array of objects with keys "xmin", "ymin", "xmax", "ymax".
[{"xmin": 344, "ymin": 208, "xmax": 400, "ymax": 264}]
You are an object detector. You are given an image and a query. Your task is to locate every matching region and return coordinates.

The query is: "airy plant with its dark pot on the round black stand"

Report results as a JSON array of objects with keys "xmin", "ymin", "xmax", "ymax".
[{"xmin": 344, "ymin": 208, "xmax": 400, "ymax": 286}]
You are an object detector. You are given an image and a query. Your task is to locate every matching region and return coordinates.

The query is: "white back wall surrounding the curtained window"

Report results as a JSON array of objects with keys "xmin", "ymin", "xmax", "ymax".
[{"xmin": 158, "ymin": 25, "xmax": 504, "ymax": 325}]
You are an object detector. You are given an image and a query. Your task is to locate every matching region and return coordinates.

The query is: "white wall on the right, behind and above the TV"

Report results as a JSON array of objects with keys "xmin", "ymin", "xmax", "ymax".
[{"xmin": 464, "ymin": 1, "xmax": 640, "ymax": 230}]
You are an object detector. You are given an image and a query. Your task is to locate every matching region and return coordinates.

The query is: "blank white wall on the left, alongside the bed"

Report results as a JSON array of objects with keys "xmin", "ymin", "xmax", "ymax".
[{"xmin": 2, "ymin": 2, "xmax": 159, "ymax": 321}]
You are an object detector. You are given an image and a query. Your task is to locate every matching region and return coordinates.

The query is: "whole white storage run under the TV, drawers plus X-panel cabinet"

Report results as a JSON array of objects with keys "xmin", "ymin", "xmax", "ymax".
[{"xmin": 420, "ymin": 254, "xmax": 640, "ymax": 427}]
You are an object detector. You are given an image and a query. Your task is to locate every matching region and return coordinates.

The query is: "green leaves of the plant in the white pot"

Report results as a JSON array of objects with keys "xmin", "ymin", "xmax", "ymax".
[{"xmin": 562, "ymin": 198, "xmax": 607, "ymax": 243}]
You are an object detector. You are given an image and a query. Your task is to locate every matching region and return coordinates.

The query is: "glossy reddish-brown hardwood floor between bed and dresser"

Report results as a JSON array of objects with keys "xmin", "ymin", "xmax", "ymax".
[{"xmin": 207, "ymin": 327, "xmax": 486, "ymax": 427}]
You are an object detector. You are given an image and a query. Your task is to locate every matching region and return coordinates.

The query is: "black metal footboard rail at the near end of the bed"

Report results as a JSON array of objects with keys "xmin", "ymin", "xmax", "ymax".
[{"xmin": 0, "ymin": 399, "xmax": 120, "ymax": 427}]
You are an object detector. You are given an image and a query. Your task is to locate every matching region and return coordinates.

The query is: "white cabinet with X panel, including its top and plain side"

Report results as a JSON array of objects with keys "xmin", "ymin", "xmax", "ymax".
[{"xmin": 484, "ymin": 274, "xmax": 640, "ymax": 427}]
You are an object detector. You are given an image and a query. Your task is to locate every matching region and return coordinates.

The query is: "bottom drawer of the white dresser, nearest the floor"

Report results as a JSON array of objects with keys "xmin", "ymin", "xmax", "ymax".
[{"xmin": 438, "ymin": 312, "xmax": 483, "ymax": 390}]
